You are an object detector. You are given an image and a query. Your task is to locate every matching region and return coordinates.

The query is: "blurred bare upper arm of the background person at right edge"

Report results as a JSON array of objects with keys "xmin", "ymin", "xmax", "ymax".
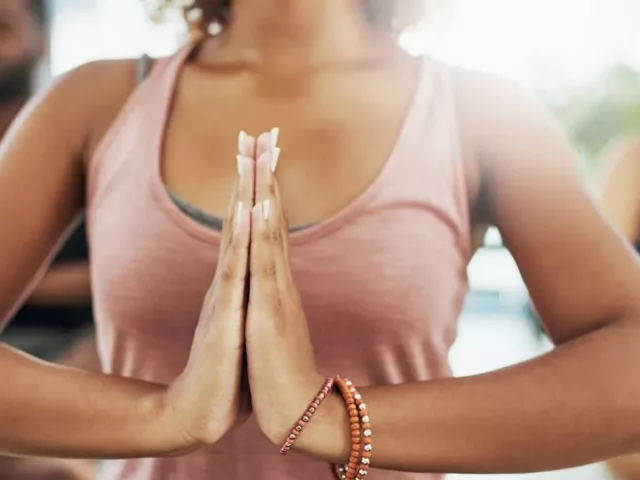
[{"xmin": 600, "ymin": 139, "xmax": 640, "ymax": 243}]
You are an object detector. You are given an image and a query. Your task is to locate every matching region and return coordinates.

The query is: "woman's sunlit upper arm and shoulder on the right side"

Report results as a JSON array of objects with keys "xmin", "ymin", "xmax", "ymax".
[{"xmin": 455, "ymin": 72, "xmax": 640, "ymax": 343}]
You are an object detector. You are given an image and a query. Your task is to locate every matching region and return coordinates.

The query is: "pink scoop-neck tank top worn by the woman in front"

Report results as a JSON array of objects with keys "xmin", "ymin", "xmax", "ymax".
[{"xmin": 87, "ymin": 48, "xmax": 470, "ymax": 480}]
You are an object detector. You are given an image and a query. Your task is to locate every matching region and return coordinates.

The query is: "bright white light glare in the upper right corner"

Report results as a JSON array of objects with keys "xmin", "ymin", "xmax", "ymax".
[{"xmin": 401, "ymin": 0, "xmax": 640, "ymax": 86}]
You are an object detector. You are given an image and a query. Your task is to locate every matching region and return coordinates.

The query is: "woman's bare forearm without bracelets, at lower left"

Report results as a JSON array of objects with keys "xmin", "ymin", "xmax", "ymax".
[{"xmin": 0, "ymin": 346, "xmax": 183, "ymax": 459}]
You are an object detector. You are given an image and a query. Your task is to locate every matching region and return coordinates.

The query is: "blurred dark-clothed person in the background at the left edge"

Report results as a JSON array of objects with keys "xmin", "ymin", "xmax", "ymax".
[{"xmin": 0, "ymin": 0, "xmax": 97, "ymax": 480}]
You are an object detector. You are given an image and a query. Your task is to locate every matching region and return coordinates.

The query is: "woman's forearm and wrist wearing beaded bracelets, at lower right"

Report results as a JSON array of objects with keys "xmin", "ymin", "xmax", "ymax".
[{"xmin": 297, "ymin": 322, "xmax": 640, "ymax": 474}]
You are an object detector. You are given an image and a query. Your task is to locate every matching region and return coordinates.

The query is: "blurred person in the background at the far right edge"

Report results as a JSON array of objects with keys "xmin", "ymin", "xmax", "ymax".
[{"xmin": 601, "ymin": 136, "xmax": 640, "ymax": 480}]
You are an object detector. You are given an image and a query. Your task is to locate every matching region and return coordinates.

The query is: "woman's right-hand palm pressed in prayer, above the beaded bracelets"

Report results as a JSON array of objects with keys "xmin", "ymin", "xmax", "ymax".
[{"xmin": 246, "ymin": 135, "xmax": 325, "ymax": 444}]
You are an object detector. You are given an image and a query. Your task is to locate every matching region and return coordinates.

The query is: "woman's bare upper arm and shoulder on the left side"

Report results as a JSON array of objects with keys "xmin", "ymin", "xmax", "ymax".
[{"xmin": 0, "ymin": 58, "xmax": 138, "ymax": 325}]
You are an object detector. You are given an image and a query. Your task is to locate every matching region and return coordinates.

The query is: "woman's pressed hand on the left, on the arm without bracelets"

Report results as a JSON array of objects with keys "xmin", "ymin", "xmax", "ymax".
[{"xmin": 162, "ymin": 134, "xmax": 255, "ymax": 450}]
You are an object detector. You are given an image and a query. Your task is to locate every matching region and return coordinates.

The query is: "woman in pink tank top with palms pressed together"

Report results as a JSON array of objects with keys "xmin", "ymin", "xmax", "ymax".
[{"xmin": 0, "ymin": 0, "xmax": 640, "ymax": 480}]
